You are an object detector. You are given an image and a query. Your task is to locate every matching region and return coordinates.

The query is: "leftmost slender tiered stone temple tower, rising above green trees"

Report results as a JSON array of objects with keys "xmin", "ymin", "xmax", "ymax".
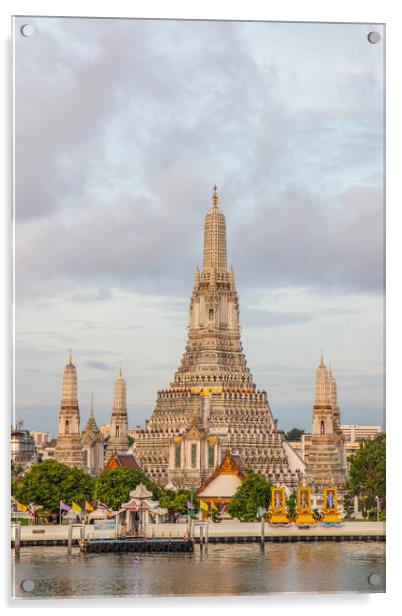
[{"xmin": 55, "ymin": 351, "xmax": 85, "ymax": 468}]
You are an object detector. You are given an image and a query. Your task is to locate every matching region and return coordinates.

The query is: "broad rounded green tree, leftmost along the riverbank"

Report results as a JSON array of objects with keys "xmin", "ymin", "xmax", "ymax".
[{"xmin": 13, "ymin": 460, "xmax": 94, "ymax": 511}]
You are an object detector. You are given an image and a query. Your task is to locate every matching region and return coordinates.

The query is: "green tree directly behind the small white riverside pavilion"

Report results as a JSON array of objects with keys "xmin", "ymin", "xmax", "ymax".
[{"xmin": 94, "ymin": 468, "xmax": 162, "ymax": 509}]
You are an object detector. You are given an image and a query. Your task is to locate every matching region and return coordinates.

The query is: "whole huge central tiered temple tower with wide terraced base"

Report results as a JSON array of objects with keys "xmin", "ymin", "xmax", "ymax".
[{"xmin": 135, "ymin": 187, "xmax": 299, "ymax": 487}]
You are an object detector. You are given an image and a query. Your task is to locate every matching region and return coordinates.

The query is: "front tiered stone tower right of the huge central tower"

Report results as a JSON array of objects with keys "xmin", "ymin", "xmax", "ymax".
[{"xmin": 303, "ymin": 353, "xmax": 346, "ymax": 505}]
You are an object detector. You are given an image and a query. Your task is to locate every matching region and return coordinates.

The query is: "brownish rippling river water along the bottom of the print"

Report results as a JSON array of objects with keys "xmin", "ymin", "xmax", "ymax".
[{"xmin": 12, "ymin": 541, "xmax": 385, "ymax": 599}]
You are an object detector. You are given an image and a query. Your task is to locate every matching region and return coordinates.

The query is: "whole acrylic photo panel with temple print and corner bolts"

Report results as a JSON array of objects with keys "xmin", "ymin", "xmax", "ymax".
[{"xmin": 11, "ymin": 16, "xmax": 386, "ymax": 599}]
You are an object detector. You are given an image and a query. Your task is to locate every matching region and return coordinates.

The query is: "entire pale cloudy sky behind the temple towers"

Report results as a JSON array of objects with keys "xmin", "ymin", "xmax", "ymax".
[{"xmin": 14, "ymin": 18, "xmax": 384, "ymax": 435}]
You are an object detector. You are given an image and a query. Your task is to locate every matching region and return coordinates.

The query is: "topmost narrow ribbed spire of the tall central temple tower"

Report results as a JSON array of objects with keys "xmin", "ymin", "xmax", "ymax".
[{"xmin": 202, "ymin": 186, "xmax": 227, "ymax": 273}]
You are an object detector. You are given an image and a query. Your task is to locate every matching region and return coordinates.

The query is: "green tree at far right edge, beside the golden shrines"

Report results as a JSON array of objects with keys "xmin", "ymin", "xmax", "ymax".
[{"xmin": 346, "ymin": 434, "xmax": 386, "ymax": 510}]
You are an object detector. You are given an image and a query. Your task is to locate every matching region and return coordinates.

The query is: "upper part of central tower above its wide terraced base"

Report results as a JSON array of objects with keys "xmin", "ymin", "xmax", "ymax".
[{"xmin": 174, "ymin": 186, "xmax": 254, "ymax": 389}]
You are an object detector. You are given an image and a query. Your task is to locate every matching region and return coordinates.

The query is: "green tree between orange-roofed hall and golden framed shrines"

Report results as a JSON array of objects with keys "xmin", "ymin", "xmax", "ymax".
[{"xmin": 228, "ymin": 470, "xmax": 271, "ymax": 522}]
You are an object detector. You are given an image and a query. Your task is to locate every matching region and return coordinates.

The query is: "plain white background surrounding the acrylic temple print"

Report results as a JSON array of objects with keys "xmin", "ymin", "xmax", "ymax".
[{"xmin": 0, "ymin": 0, "xmax": 402, "ymax": 616}]
